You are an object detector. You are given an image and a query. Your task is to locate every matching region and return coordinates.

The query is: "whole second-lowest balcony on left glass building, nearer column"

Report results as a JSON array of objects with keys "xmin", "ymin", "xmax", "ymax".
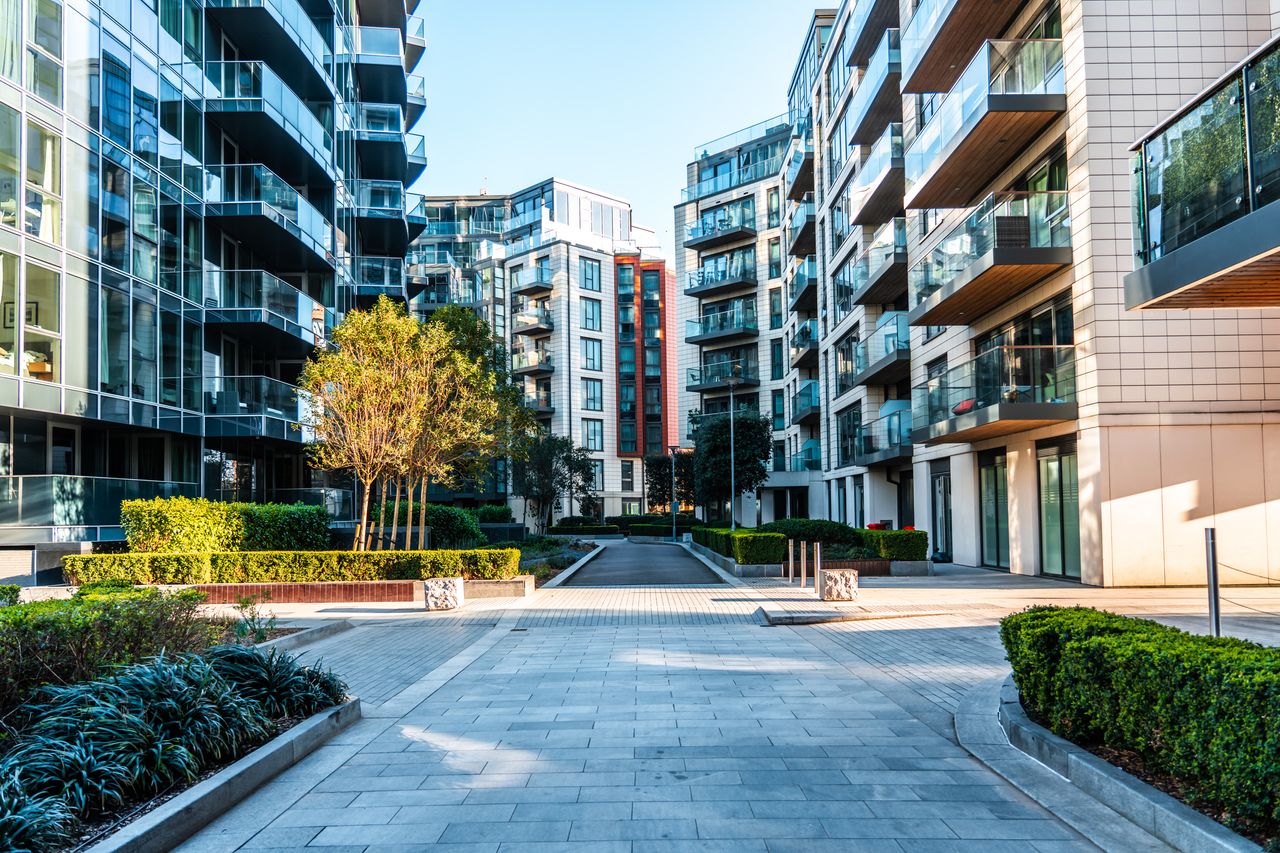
[{"xmin": 204, "ymin": 269, "xmax": 337, "ymax": 359}]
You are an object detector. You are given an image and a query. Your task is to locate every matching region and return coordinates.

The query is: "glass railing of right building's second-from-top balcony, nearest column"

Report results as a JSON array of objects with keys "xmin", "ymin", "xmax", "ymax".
[{"xmin": 904, "ymin": 39, "xmax": 1066, "ymax": 189}]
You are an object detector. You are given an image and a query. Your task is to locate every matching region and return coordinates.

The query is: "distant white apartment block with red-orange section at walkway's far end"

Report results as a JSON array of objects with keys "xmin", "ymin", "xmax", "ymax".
[{"xmin": 403, "ymin": 179, "xmax": 677, "ymax": 517}]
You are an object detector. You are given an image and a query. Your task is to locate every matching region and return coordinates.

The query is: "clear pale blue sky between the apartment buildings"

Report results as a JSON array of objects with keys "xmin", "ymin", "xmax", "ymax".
[{"xmin": 416, "ymin": 0, "xmax": 819, "ymax": 254}]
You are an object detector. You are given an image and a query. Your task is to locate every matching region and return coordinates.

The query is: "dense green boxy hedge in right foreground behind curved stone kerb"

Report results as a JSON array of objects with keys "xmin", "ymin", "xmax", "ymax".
[{"xmin": 1000, "ymin": 607, "xmax": 1280, "ymax": 840}]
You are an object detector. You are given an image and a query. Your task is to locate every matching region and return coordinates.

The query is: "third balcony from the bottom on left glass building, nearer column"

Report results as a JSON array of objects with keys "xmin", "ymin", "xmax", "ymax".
[{"xmin": 205, "ymin": 164, "xmax": 334, "ymax": 272}]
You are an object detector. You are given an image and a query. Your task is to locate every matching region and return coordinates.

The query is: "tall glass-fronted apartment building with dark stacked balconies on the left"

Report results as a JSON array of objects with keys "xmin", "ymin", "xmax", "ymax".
[{"xmin": 0, "ymin": 0, "xmax": 426, "ymax": 544}]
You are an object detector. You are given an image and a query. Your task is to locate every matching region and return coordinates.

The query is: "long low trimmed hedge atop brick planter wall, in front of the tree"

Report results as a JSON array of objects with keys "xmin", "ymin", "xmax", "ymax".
[{"xmin": 63, "ymin": 548, "xmax": 520, "ymax": 584}]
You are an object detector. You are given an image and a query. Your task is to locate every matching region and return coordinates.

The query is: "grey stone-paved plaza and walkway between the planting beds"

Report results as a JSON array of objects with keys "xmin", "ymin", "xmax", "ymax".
[{"xmin": 182, "ymin": 542, "xmax": 1280, "ymax": 853}]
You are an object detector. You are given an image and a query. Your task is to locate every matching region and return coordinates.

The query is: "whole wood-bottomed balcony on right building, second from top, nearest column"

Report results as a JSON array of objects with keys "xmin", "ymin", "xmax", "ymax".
[{"xmin": 905, "ymin": 38, "xmax": 1066, "ymax": 207}]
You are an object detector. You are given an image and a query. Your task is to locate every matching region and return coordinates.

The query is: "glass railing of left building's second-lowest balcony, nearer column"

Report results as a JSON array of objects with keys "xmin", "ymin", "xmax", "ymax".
[{"xmin": 204, "ymin": 269, "xmax": 337, "ymax": 341}]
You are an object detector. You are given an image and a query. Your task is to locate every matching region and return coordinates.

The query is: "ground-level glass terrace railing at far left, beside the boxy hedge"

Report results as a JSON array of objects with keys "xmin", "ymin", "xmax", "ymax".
[{"xmin": 0, "ymin": 474, "xmax": 200, "ymax": 528}]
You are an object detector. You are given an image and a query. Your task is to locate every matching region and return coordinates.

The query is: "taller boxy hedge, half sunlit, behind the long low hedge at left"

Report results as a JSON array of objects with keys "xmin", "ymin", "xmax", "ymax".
[{"xmin": 120, "ymin": 497, "xmax": 329, "ymax": 553}]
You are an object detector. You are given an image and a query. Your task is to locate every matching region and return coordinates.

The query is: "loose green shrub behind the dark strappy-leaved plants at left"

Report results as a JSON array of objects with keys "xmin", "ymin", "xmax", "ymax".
[{"xmin": 0, "ymin": 589, "xmax": 218, "ymax": 717}]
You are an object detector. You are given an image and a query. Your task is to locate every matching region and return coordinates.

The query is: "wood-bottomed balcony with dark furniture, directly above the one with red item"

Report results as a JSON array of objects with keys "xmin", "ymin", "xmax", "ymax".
[{"xmin": 908, "ymin": 192, "xmax": 1071, "ymax": 325}]
